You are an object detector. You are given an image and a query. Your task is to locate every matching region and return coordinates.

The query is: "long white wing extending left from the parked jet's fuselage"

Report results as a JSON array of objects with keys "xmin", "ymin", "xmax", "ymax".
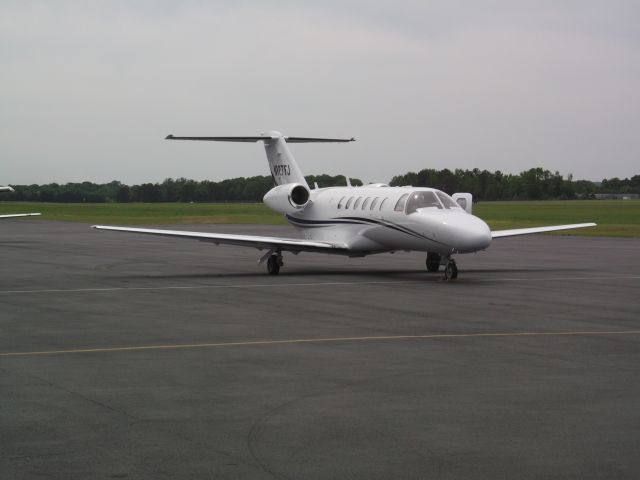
[{"xmin": 93, "ymin": 225, "xmax": 349, "ymax": 254}]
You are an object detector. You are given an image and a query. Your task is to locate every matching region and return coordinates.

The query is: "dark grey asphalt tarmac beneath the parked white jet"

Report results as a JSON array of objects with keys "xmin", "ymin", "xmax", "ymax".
[{"xmin": 0, "ymin": 219, "xmax": 640, "ymax": 480}]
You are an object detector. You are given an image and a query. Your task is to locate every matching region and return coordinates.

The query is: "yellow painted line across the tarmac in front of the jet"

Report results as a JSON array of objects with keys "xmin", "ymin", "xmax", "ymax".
[{"xmin": 0, "ymin": 330, "xmax": 640, "ymax": 357}]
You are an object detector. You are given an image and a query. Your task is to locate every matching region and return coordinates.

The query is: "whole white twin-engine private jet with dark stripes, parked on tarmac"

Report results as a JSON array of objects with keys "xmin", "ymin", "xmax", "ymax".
[{"xmin": 93, "ymin": 131, "xmax": 595, "ymax": 280}]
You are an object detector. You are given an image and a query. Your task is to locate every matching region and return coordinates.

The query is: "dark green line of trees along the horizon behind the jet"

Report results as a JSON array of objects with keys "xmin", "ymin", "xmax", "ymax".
[{"xmin": 2, "ymin": 168, "xmax": 640, "ymax": 203}]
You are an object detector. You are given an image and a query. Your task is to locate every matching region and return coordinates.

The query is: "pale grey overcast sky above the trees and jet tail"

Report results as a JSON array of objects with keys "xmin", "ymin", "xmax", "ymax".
[{"xmin": 0, "ymin": 0, "xmax": 640, "ymax": 184}]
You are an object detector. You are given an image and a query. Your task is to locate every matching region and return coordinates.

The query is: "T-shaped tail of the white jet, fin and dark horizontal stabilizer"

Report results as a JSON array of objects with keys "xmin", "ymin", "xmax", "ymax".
[{"xmin": 167, "ymin": 131, "xmax": 355, "ymax": 190}]
